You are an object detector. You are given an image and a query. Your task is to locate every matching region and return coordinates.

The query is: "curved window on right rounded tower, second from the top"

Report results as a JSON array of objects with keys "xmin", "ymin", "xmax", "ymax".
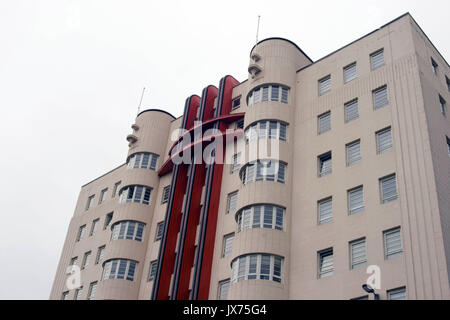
[{"xmin": 245, "ymin": 120, "xmax": 287, "ymax": 144}]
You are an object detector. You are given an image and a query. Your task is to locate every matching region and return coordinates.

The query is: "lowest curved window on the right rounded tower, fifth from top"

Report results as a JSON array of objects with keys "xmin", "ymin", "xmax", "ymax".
[{"xmin": 231, "ymin": 253, "xmax": 284, "ymax": 283}]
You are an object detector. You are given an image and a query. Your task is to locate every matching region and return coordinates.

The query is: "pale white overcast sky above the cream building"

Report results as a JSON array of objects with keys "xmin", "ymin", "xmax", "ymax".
[{"xmin": 0, "ymin": 0, "xmax": 450, "ymax": 299}]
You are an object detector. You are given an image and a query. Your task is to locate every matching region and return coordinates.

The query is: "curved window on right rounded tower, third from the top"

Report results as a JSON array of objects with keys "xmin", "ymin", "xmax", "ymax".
[{"xmin": 240, "ymin": 160, "xmax": 286, "ymax": 185}]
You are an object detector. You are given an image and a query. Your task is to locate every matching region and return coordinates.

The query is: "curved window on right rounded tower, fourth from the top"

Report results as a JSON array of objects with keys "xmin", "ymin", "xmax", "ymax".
[{"xmin": 236, "ymin": 204, "xmax": 286, "ymax": 232}]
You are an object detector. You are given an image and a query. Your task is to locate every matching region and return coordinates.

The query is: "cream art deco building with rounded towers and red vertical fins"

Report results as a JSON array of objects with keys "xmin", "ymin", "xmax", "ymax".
[{"xmin": 51, "ymin": 14, "xmax": 450, "ymax": 299}]
